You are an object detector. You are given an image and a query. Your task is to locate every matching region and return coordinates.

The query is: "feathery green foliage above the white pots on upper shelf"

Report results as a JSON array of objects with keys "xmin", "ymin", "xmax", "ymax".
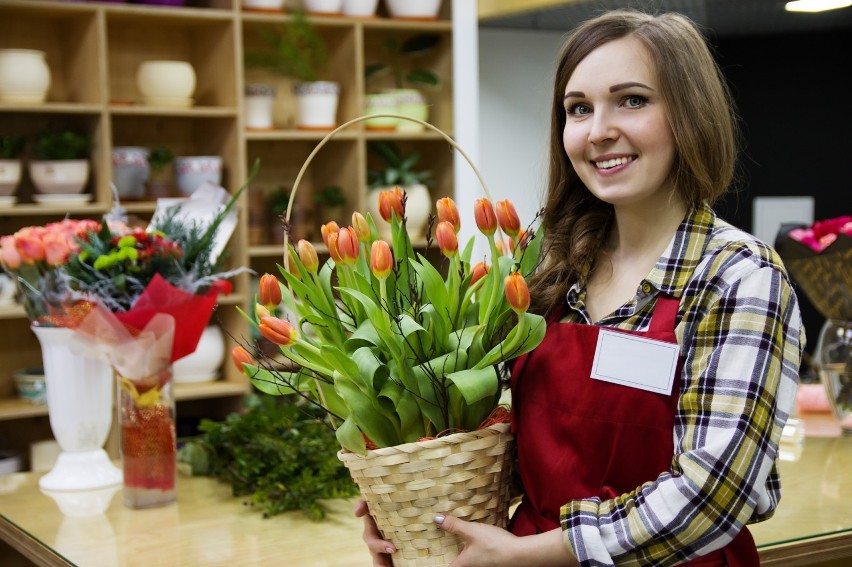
[{"xmin": 245, "ymin": 11, "xmax": 329, "ymax": 82}]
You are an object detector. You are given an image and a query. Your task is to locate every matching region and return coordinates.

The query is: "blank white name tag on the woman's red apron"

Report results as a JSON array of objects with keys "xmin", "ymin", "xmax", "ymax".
[{"xmin": 592, "ymin": 329, "xmax": 678, "ymax": 394}]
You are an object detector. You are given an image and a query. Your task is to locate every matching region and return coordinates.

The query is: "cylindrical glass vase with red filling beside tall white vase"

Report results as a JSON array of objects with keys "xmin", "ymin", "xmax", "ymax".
[{"xmin": 119, "ymin": 366, "xmax": 177, "ymax": 508}]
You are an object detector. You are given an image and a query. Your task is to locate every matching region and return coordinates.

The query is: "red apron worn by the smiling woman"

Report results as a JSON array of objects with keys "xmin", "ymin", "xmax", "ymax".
[{"xmin": 510, "ymin": 296, "xmax": 760, "ymax": 567}]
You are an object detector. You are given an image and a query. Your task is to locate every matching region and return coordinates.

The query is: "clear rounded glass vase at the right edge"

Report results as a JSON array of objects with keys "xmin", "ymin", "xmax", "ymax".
[{"xmin": 815, "ymin": 319, "xmax": 852, "ymax": 435}]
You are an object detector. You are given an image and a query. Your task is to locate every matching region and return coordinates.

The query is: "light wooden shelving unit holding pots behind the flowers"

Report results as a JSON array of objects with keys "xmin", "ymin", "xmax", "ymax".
[{"xmin": 0, "ymin": 0, "xmax": 454, "ymax": 464}]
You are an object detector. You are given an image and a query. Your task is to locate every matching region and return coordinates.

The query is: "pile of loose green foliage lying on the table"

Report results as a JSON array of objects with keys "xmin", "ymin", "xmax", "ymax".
[{"xmin": 179, "ymin": 396, "xmax": 358, "ymax": 520}]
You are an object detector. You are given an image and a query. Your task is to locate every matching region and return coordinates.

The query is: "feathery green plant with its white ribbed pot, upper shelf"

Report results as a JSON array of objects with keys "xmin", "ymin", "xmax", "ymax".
[{"xmin": 245, "ymin": 11, "xmax": 340, "ymax": 130}]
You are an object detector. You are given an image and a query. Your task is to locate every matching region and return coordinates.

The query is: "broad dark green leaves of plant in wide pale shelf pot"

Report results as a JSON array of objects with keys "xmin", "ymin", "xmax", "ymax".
[{"xmin": 364, "ymin": 33, "xmax": 441, "ymax": 89}]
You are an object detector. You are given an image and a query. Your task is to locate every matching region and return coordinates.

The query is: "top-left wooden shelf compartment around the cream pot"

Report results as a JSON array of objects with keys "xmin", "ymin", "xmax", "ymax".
[{"xmin": 0, "ymin": 2, "xmax": 103, "ymax": 104}]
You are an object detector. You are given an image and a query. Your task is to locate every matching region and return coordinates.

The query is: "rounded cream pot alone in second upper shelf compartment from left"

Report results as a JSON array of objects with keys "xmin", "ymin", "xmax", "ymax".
[{"xmin": 136, "ymin": 60, "xmax": 196, "ymax": 107}]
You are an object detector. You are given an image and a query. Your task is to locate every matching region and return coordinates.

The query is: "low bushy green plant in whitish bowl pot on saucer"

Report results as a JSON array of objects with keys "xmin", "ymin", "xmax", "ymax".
[{"xmin": 29, "ymin": 130, "xmax": 89, "ymax": 202}]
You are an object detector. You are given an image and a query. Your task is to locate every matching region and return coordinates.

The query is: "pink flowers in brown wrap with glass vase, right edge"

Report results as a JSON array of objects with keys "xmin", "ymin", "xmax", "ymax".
[{"xmin": 775, "ymin": 216, "xmax": 852, "ymax": 433}]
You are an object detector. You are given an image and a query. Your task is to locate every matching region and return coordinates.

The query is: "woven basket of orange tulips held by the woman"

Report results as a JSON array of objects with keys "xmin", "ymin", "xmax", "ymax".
[{"xmin": 234, "ymin": 119, "xmax": 545, "ymax": 565}]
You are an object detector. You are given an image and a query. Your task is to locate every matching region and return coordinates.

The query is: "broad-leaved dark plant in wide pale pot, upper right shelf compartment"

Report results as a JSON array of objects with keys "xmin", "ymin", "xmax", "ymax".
[{"xmin": 364, "ymin": 33, "xmax": 441, "ymax": 131}]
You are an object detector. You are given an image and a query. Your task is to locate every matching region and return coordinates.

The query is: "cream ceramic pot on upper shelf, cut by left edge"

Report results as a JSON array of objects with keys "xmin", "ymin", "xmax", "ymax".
[{"xmin": 0, "ymin": 49, "xmax": 50, "ymax": 104}]
